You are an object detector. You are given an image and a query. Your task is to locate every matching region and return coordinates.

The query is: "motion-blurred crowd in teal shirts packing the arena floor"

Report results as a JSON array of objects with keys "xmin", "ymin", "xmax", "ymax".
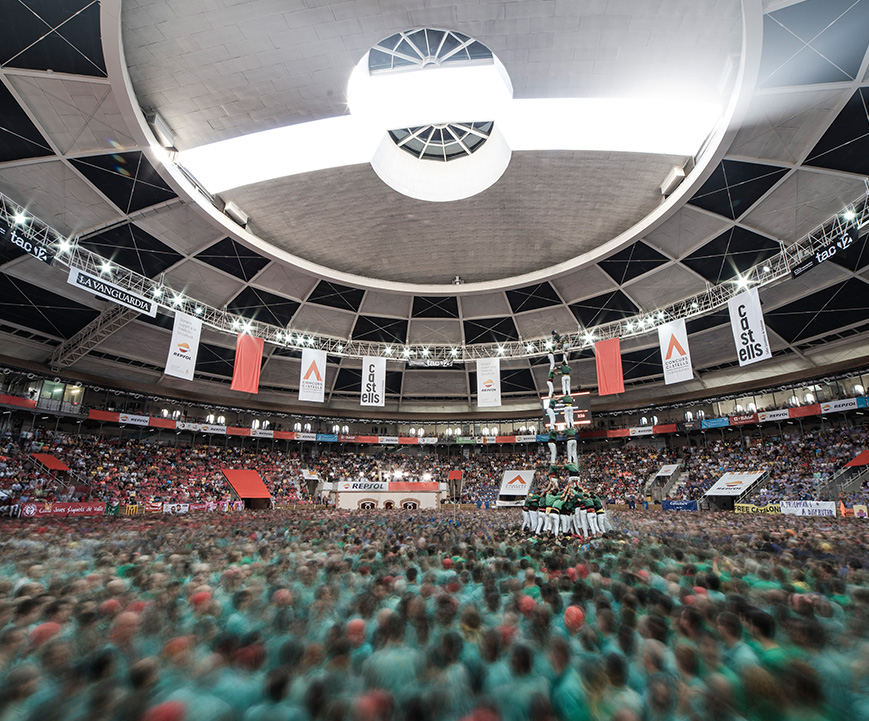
[{"xmin": 0, "ymin": 510, "xmax": 869, "ymax": 721}]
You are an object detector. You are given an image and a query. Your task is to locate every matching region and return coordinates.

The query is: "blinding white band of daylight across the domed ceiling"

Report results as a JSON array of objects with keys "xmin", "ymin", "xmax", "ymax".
[{"xmin": 177, "ymin": 78, "xmax": 721, "ymax": 193}]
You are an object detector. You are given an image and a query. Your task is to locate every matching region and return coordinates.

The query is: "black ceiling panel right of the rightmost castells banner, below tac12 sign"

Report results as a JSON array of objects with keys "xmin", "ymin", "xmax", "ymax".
[{"xmin": 764, "ymin": 278, "xmax": 869, "ymax": 343}]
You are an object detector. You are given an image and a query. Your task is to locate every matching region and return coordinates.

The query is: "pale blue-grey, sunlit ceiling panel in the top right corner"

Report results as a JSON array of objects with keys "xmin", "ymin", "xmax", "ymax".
[{"xmin": 759, "ymin": 0, "xmax": 869, "ymax": 88}]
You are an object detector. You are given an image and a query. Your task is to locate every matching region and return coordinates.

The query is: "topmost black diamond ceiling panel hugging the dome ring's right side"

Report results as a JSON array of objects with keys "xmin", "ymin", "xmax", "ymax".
[{"xmin": 688, "ymin": 160, "xmax": 787, "ymax": 220}]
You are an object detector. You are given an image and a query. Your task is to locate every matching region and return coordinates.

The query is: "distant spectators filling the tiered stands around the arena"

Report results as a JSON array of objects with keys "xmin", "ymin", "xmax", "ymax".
[{"xmin": 0, "ymin": 427, "xmax": 869, "ymax": 507}]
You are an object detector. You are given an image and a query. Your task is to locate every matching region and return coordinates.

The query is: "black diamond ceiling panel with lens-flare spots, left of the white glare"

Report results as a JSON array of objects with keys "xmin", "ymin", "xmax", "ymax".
[{"xmin": 70, "ymin": 150, "xmax": 177, "ymax": 213}]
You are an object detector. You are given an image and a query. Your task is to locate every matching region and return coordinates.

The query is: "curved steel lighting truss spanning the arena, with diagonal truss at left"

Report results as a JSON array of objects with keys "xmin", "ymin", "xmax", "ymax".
[{"xmin": 0, "ymin": 182, "xmax": 869, "ymax": 366}]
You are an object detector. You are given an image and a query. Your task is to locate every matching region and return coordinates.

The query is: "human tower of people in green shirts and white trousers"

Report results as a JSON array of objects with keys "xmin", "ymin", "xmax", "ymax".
[{"xmin": 521, "ymin": 331, "xmax": 612, "ymax": 537}]
